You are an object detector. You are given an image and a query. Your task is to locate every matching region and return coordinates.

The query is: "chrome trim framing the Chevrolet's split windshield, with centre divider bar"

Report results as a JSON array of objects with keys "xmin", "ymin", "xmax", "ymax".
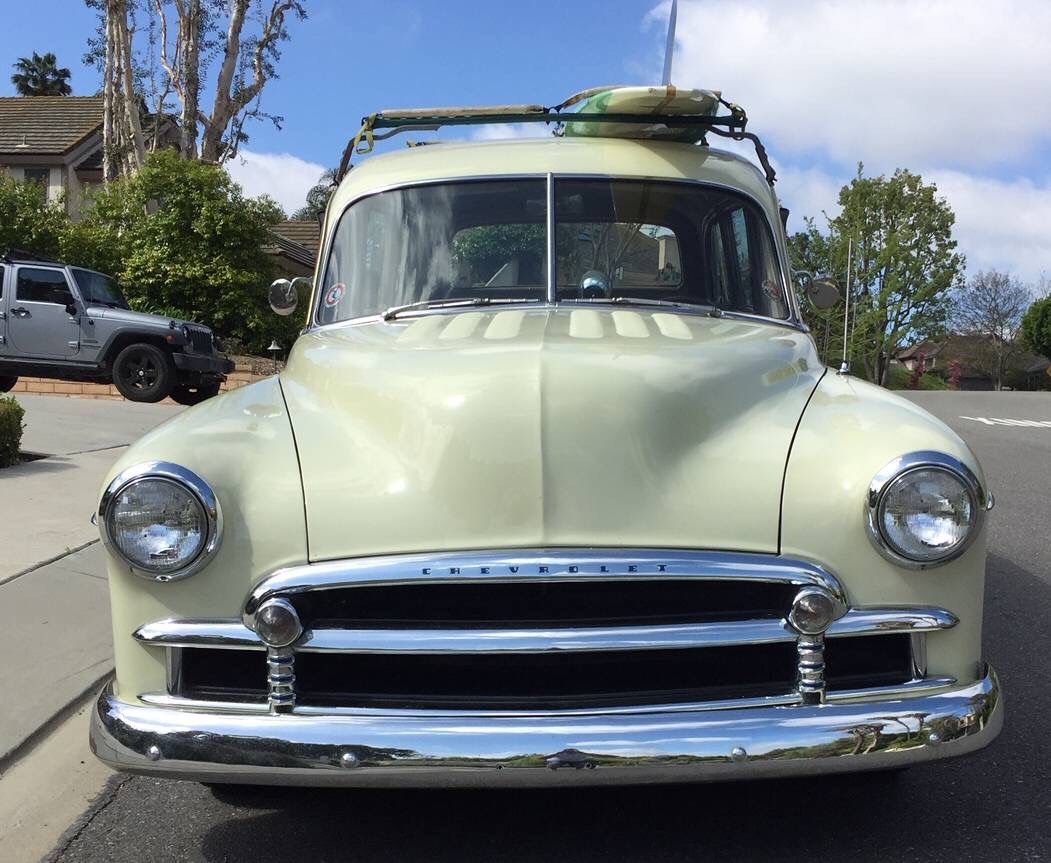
[{"xmin": 303, "ymin": 171, "xmax": 809, "ymax": 333}]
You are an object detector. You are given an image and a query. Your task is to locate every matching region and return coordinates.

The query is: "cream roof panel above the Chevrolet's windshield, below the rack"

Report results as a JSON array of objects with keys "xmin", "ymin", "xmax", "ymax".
[{"xmin": 332, "ymin": 137, "xmax": 779, "ymax": 223}]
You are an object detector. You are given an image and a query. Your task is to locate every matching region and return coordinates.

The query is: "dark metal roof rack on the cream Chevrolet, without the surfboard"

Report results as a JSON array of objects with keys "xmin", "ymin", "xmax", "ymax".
[{"xmin": 334, "ymin": 88, "xmax": 777, "ymax": 186}]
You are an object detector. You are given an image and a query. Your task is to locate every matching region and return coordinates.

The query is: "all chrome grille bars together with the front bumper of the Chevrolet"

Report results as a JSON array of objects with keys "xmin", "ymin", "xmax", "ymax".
[{"xmin": 90, "ymin": 549, "xmax": 1003, "ymax": 786}]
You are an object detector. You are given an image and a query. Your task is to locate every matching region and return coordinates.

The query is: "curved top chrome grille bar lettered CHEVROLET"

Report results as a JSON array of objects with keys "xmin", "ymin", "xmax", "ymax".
[{"xmin": 242, "ymin": 548, "xmax": 847, "ymax": 629}]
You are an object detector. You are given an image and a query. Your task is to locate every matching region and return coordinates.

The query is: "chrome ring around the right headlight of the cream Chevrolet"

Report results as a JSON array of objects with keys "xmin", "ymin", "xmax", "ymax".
[{"xmin": 865, "ymin": 450, "xmax": 992, "ymax": 570}]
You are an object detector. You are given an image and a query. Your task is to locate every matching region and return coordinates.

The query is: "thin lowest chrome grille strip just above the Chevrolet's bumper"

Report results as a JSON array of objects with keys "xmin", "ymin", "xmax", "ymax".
[{"xmin": 139, "ymin": 677, "xmax": 956, "ymax": 719}]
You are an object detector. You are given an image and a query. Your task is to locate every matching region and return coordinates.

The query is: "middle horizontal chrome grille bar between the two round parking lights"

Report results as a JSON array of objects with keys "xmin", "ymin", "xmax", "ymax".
[{"xmin": 141, "ymin": 607, "xmax": 957, "ymax": 654}]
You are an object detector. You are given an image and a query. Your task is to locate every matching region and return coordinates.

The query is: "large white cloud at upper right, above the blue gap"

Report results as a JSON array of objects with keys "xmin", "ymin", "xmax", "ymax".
[{"xmin": 664, "ymin": 0, "xmax": 1051, "ymax": 170}]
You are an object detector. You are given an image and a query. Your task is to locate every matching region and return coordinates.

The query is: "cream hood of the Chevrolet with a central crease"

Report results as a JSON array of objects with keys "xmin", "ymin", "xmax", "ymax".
[{"xmin": 281, "ymin": 308, "xmax": 824, "ymax": 560}]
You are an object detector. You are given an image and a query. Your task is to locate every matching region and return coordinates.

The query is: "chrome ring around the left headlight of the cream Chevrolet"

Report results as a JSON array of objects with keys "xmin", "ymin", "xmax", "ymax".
[{"xmin": 99, "ymin": 461, "xmax": 223, "ymax": 582}]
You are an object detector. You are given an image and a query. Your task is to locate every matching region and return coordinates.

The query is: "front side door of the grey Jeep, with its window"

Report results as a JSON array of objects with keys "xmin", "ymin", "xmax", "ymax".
[{"xmin": 7, "ymin": 266, "xmax": 80, "ymax": 359}]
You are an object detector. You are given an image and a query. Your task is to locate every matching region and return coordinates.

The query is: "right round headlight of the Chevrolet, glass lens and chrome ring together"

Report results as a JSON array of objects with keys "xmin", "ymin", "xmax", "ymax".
[{"xmin": 868, "ymin": 453, "xmax": 986, "ymax": 567}]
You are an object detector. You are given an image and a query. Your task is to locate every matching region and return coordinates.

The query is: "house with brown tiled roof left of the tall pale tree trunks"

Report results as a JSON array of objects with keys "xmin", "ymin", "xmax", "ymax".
[{"xmin": 0, "ymin": 96, "xmax": 102, "ymax": 218}]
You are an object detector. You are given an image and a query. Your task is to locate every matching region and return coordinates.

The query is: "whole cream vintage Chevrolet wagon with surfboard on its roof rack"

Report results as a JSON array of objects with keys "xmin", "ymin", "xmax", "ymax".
[{"xmin": 91, "ymin": 87, "xmax": 1003, "ymax": 785}]
